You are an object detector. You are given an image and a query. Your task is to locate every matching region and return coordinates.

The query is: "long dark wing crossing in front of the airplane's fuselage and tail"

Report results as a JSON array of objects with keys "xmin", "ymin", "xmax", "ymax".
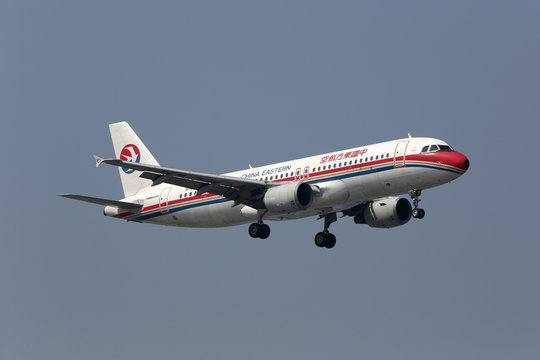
[{"xmin": 95, "ymin": 157, "xmax": 277, "ymax": 209}]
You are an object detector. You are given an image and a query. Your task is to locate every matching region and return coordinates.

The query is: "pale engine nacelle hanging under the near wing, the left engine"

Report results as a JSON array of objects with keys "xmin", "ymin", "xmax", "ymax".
[{"xmin": 263, "ymin": 182, "xmax": 313, "ymax": 214}]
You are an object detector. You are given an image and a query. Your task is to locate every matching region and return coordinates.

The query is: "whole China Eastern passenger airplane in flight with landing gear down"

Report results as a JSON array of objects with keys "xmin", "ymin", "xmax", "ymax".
[{"xmin": 59, "ymin": 122, "xmax": 470, "ymax": 249}]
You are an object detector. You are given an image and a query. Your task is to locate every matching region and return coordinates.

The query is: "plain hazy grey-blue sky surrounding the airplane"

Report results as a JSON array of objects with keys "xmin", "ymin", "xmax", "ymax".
[{"xmin": 0, "ymin": 0, "xmax": 540, "ymax": 360}]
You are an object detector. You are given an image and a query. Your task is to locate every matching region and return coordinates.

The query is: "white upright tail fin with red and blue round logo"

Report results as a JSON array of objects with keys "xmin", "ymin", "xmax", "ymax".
[{"xmin": 109, "ymin": 121, "xmax": 159, "ymax": 197}]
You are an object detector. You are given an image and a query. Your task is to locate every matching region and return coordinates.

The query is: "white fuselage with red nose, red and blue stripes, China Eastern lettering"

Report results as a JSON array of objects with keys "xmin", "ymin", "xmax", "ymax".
[{"xmin": 110, "ymin": 138, "xmax": 468, "ymax": 227}]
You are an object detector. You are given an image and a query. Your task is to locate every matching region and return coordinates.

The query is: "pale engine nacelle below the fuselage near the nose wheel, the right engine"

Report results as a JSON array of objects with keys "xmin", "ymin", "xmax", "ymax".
[{"xmin": 354, "ymin": 197, "xmax": 412, "ymax": 228}]
